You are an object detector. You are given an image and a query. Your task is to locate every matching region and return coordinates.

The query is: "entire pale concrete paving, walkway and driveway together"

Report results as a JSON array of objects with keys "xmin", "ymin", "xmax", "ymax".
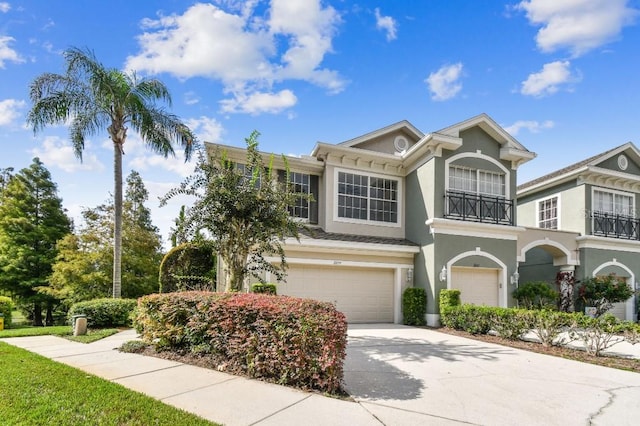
[{"xmin": 0, "ymin": 324, "xmax": 640, "ymax": 426}]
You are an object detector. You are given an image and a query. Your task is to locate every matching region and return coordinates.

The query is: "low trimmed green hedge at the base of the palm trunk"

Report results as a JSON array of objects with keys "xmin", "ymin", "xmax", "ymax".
[{"xmin": 67, "ymin": 298, "xmax": 136, "ymax": 327}]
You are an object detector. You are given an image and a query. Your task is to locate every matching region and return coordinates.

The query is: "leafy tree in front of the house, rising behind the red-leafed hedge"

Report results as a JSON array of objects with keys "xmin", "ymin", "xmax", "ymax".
[{"xmin": 161, "ymin": 131, "xmax": 304, "ymax": 291}]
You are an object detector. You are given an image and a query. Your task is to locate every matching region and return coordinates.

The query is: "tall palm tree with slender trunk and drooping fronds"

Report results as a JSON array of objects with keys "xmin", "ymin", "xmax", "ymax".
[{"xmin": 27, "ymin": 48, "xmax": 194, "ymax": 298}]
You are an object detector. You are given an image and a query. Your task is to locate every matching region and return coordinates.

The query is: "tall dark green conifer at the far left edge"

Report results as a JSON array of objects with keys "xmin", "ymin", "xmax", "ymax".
[{"xmin": 0, "ymin": 158, "xmax": 71, "ymax": 326}]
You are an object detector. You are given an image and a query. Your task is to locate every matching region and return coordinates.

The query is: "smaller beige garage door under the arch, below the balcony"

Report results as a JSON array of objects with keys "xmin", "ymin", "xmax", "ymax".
[{"xmin": 451, "ymin": 267, "xmax": 500, "ymax": 306}]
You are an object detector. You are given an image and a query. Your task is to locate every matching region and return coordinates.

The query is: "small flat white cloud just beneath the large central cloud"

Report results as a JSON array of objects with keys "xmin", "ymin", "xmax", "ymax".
[{"xmin": 220, "ymin": 90, "xmax": 298, "ymax": 115}]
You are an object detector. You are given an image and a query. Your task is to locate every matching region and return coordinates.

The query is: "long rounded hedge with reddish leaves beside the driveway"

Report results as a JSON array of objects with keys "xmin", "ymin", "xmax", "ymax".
[{"xmin": 136, "ymin": 292, "xmax": 347, "ymax": 392}]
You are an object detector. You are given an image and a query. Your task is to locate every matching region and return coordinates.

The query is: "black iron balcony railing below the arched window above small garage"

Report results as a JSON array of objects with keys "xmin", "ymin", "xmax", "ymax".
[{"xmin": 444, "ymin": 191, "xmax": 514, "ymax": 225}]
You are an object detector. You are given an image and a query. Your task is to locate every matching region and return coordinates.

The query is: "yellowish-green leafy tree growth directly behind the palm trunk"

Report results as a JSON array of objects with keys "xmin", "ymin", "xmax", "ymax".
[{"xmin": 51, "ymin": 171, "xmax": 162, "ymax": 304}]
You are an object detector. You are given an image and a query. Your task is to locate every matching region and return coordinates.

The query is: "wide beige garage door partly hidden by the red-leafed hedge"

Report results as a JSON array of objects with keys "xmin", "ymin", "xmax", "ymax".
[{"xmin": 278, "ymin": 265, "xmax": 394, "ymax": 322}]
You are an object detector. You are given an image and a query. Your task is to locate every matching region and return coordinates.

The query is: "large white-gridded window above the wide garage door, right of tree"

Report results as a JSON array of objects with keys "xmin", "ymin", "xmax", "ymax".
[{"xmin": 337, "ymin": 172, "xmax": 398, "ymax": 223}]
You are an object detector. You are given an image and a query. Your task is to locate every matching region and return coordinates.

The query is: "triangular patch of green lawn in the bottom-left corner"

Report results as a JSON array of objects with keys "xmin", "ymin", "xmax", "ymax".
[{"xmin": 0, "ymin": 342, "xmax": 218, "ymax": 426}]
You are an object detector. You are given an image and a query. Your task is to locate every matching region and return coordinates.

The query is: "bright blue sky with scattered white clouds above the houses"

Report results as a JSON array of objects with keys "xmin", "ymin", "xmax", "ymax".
[{"xmin": 0, "ymin": 0, "xmax": 640, "ymax": 246}]
